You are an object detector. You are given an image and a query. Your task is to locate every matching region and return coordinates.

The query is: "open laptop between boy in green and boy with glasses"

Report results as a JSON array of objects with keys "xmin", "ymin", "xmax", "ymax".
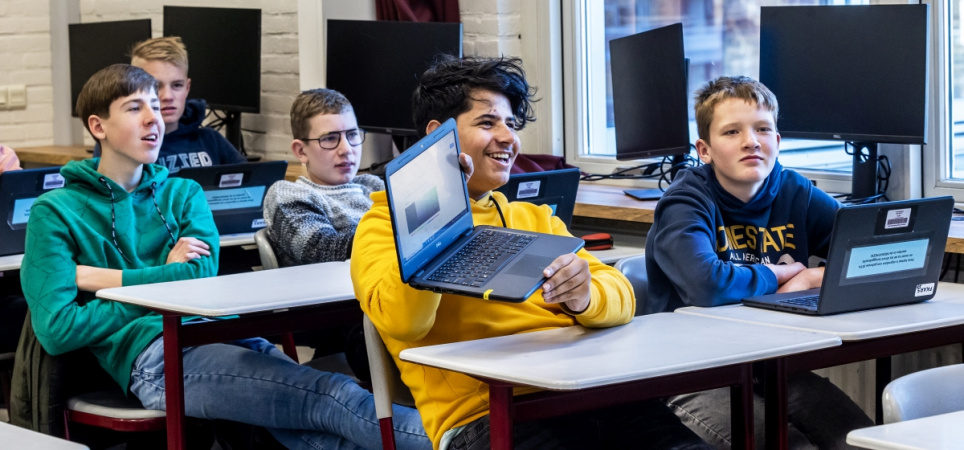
[{"xmin": 171, "ymin": 161, "xmax": 288, "ymax": 235}]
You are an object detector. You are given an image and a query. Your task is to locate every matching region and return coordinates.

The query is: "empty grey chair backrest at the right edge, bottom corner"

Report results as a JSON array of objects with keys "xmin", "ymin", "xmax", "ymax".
[{"xmin": 881, "ymin": 364, "xmax": 964, "ymax": 423}]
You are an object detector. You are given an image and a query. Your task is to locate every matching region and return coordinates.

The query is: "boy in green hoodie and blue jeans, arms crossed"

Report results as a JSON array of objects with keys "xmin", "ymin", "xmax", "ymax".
[{"xmin": 21, "ymin": 64, "xmax": 430, "ymax": 449}]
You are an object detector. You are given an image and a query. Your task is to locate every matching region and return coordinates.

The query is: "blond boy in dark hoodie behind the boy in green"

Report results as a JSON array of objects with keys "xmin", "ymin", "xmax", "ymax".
[{"xmin": 94, "ymin": 36, "xmax": 247, "ymax": 174}]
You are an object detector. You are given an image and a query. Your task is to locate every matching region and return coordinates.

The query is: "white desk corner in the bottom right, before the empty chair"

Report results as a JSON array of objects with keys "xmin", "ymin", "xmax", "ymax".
[{"xmin": 847, "ymin": 411, "xmax": 964, "ymax": 450}]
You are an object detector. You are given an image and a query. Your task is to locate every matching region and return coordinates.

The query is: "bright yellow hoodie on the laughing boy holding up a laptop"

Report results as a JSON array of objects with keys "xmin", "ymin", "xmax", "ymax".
[{"xmin": 351, "ymin": 191, "xmax": 636, "ymax": 448}]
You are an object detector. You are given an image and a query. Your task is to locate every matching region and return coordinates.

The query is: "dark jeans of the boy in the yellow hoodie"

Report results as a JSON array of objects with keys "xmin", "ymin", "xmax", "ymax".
[{"xmin": 449, "ymin": 400, "xmax": 713, "ymax": 450}]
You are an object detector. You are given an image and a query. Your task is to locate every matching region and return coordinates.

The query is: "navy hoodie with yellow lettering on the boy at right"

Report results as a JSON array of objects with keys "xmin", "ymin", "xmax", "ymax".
[{"xmin": 637, "ymin": 162, "xmax": 840, "ymax": 314}]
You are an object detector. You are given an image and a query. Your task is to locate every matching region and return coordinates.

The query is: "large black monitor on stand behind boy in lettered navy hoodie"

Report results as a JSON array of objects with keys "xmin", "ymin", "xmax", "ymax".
[{"xmin": 760, "ymin": 4, "xmax": 930, "ymax": 199}]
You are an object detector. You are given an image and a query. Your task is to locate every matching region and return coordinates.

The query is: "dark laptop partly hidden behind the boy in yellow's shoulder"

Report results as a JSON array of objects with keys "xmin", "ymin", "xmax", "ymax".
[{"xmin": 496, "ymin": 168, "xmax": 581, "ymax": 228}]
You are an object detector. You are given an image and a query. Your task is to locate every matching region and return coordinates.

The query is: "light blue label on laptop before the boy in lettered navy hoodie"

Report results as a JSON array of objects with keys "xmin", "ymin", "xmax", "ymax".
[{"xmin": 844, "ymin": 239, "xmax": 928, "ymax": 279}]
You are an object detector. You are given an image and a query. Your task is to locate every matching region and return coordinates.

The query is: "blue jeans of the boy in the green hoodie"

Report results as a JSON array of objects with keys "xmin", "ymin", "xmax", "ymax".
[{"xmin": 131, "ymin": 338, "xmax": 432, "ymax": 449}]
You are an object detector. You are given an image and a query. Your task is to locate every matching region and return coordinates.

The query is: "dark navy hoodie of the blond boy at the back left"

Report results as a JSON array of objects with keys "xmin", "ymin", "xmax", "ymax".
[{"xmin": 94, "ymin": 99, "xmax": 247, "ymax": 174}]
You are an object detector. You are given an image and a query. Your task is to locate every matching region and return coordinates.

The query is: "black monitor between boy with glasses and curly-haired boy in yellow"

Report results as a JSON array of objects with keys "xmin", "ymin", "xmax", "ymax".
[{"xmin": 326, "ymin": 20, "xmax": 462, "ymax": 136}]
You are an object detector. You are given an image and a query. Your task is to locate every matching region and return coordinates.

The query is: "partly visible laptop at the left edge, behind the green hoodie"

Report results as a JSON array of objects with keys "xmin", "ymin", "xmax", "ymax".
[{"xmin": 0, "ymin": 166, "xmax": 65, "ymax": 255}]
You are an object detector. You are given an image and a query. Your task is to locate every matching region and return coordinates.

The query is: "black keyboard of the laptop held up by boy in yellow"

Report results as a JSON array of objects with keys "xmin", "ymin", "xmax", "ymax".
[{"xmin": 428, "ymin": 230, "xmax": 535, "ymax": 287}]
